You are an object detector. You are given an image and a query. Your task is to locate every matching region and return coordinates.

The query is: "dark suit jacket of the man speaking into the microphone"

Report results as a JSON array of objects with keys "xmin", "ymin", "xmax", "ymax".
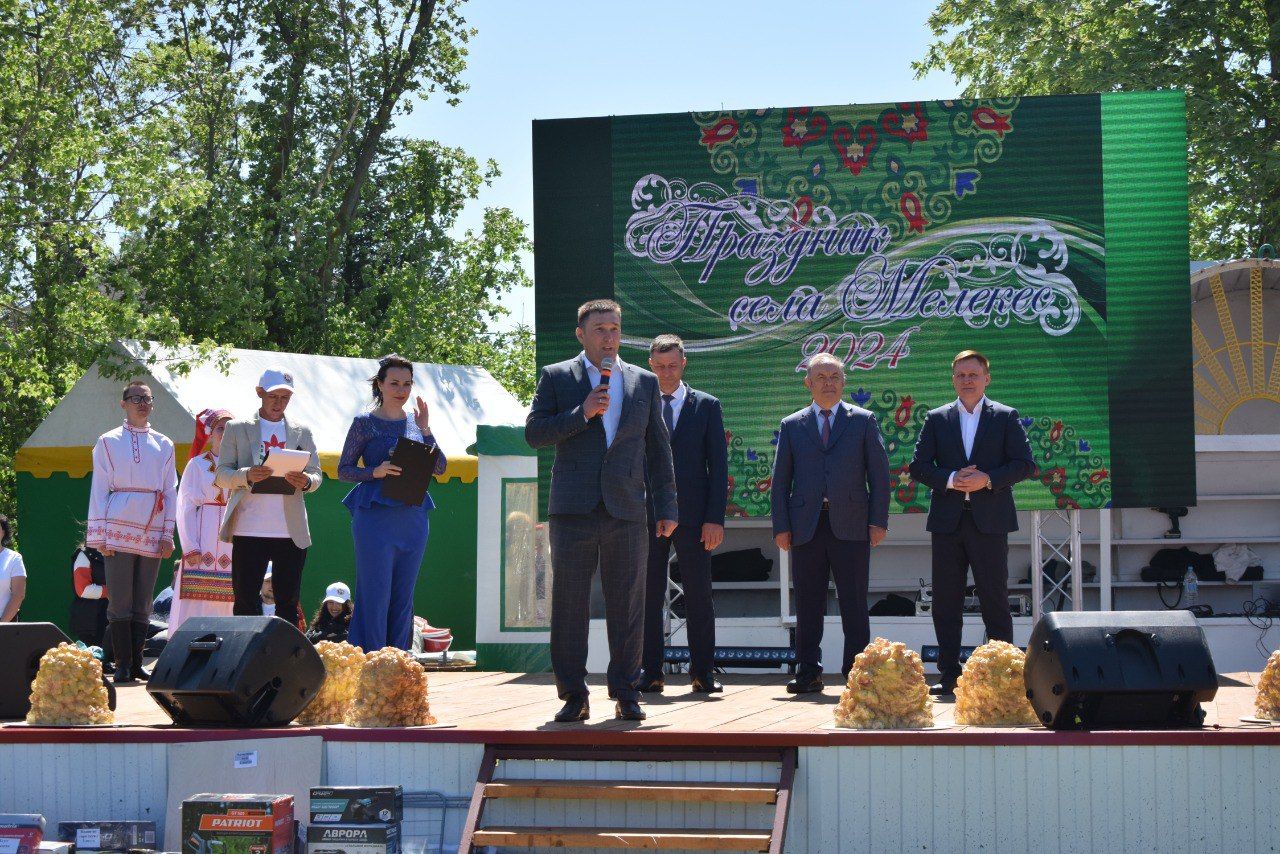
[{"xmin": 525, "ymin": 356, "xmax": 676, "ymax": 522}]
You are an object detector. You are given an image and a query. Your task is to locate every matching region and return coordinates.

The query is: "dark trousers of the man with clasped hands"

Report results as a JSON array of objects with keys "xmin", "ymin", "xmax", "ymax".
[{"xmin": 933, "ymin": 510, "xmax": 1014, "ymax": 681}]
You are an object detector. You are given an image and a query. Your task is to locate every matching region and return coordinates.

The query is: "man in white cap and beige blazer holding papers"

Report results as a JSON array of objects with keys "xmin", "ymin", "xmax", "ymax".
[{"xmin": 215, "ymin": 367, "xmax": 321, "ymax": 627}]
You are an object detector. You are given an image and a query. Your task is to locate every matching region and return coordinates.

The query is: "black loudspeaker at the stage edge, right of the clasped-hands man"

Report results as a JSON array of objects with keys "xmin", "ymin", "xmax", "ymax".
[{"xmin": 1024, "ymin": 611, "xmax": 1217, "ymax": 730}]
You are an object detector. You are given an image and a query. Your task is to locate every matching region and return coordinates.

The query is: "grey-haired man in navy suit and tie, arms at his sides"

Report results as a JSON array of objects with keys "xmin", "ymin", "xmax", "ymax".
[{"xmin": 772, "ymin": 353, "xmax": 888, "ymax": 694}]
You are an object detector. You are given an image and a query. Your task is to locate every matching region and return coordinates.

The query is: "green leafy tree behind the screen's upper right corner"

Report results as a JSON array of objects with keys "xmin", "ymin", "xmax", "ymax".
[{"xmin": 914, "ymin": 0, "xmax": 1280, "ymax": 259}]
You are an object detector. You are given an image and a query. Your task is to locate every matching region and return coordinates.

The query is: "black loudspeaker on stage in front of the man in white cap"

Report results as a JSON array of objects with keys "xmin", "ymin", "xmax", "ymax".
[{"xmin": 147, "ymin": 617, "xmax": 324, "ymax": 727}]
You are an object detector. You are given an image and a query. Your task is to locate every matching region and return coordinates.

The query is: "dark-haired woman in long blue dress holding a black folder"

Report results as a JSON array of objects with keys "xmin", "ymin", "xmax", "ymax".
[{"xmin": 338, "ymin": 353, "xmax": 447, "ymax": 652}]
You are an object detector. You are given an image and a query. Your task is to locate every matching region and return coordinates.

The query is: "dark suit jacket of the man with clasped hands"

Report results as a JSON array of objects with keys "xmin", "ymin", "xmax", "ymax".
[{"xmin": 910, "ymin": 399, "xmax": 1036, "ymax": 534}]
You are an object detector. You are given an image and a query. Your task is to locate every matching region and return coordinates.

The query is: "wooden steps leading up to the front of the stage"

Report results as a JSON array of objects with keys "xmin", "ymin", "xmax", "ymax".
[{"xmin": 458, "ymin": 744, "xmax": 796, "ymax": 854}]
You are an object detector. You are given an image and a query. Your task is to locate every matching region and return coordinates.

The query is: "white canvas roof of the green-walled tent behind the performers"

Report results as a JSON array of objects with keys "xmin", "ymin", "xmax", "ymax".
[{"xmin": 19, "ymin": 342, "xmax": 526, "ymax": 480}]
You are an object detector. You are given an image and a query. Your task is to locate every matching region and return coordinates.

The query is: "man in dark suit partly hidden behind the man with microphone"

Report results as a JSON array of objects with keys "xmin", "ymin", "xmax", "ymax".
[{"xmin": 640, "ymin": 335, "xmax": 728, "ymax": 694}]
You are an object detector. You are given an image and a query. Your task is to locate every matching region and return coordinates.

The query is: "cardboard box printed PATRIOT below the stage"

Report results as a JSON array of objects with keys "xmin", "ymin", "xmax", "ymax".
[{"xmin": 182, "ymin": 794, "xmax": 293, "ymax": 854}]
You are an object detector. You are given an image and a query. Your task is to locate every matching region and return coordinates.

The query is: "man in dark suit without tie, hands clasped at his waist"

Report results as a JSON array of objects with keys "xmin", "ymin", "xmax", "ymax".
[{"xmin": 910, "ymin": 350, "xmax": 1036, "ymax": 695}]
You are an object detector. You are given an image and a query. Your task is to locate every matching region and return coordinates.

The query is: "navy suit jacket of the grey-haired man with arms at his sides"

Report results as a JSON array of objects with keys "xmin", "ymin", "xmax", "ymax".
[{"xmin": 772, "ymin": 402, "xmax": 888, "ymax": 545}]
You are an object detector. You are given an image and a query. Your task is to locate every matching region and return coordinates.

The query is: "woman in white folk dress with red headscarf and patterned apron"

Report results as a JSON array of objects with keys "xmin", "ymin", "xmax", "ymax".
[{"xmin": 169, "ymin": 410, "xmax": 236, "ymax": 636}]
